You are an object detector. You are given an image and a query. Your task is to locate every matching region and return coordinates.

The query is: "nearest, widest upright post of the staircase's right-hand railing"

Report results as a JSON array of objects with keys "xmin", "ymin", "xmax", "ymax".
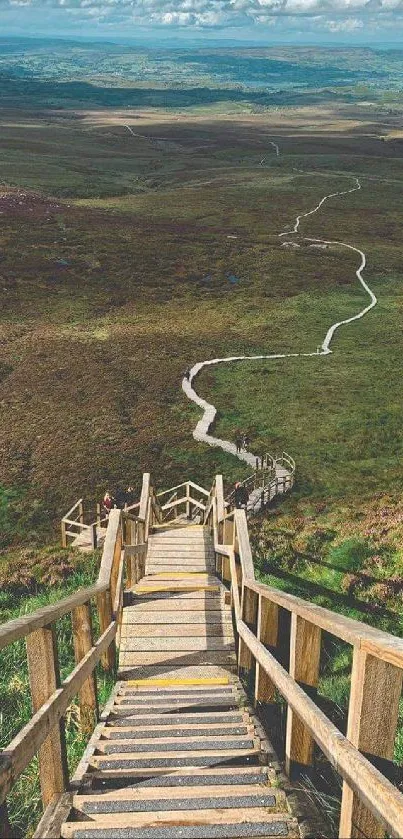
[{"xmin": 339, "ymin": 647, "xmax": 403, "ymax": 839}]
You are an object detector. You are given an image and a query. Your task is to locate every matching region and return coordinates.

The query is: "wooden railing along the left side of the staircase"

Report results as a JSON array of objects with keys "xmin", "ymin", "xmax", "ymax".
[{"xmin": 0, "ymin": 475, "xmax": 161, "ymax": 836}]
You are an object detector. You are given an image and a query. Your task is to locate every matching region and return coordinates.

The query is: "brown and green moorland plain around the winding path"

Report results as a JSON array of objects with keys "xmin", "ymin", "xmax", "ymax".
[{"xmin": 0, "ymin": 109, "xmax": 403, "ymax": 540}]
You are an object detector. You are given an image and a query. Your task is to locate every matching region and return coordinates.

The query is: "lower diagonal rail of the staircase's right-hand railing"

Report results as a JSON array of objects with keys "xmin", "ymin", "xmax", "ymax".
[{"xmin": 238, "ymin": 621, "xmax": 403, "ymax": 837}]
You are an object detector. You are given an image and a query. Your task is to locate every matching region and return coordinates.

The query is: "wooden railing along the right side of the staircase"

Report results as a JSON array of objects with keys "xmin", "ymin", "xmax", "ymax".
[{"xmin": 206, "ymin": 476, "xmax": 403, "ymax": 839}]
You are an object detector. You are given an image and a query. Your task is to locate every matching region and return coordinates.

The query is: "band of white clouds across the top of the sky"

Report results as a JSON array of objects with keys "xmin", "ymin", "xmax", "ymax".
[{"xmin": 0, "ymin": 0, "xmax": 403, "ymax": 35}]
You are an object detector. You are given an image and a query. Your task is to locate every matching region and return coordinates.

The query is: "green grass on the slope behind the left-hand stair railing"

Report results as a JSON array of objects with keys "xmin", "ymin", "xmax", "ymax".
[{"xmin": 0, "ymin": 554, "xmax": 113, "ymax": 839}]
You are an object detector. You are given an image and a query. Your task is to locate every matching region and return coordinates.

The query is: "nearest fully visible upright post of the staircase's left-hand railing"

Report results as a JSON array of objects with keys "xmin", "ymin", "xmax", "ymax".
[{"xmin": 26, "ymin": 624, "xmax": 68, "ymax": 807}]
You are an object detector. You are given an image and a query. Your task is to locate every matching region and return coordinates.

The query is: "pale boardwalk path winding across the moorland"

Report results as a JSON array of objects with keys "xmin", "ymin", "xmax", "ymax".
[{"xmin": 182, "ymin": 143, "xmax": 378, "ymax": 468}]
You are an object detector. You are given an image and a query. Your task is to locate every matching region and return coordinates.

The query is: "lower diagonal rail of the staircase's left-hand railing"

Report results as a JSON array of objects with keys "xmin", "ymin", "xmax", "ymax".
[{"xmin": 0, "ymin": 623, "xmax": 116, "ymax": 801}]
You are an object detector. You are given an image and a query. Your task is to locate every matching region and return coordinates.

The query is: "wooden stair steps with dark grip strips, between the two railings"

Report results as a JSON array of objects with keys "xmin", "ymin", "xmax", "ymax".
[{"xmin": 61, "ymin": 525, "xmax": 299, "ymax": 839}]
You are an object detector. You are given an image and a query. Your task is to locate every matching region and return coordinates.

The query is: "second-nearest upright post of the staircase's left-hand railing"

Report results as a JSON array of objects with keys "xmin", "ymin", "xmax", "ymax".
[{"xmin": 71, "ymin": 603, "xmax": 99, "ymax": 734}]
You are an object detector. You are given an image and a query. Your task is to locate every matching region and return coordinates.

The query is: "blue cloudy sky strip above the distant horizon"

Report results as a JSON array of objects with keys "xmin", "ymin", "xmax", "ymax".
[{"xmin": 0, "ymin": 0, "xmax": 403, "ymax": 46}]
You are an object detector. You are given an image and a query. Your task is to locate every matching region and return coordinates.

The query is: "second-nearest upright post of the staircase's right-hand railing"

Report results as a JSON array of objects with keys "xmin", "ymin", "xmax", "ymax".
[{"xmin": 285, "ymin": 613, "xmax": 322, "ymax": 777}]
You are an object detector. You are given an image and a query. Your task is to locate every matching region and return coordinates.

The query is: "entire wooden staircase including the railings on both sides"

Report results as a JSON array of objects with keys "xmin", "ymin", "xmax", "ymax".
[{"xmin": 0, "ymin": 474, "xmax": 403, "ymax": 839}]
